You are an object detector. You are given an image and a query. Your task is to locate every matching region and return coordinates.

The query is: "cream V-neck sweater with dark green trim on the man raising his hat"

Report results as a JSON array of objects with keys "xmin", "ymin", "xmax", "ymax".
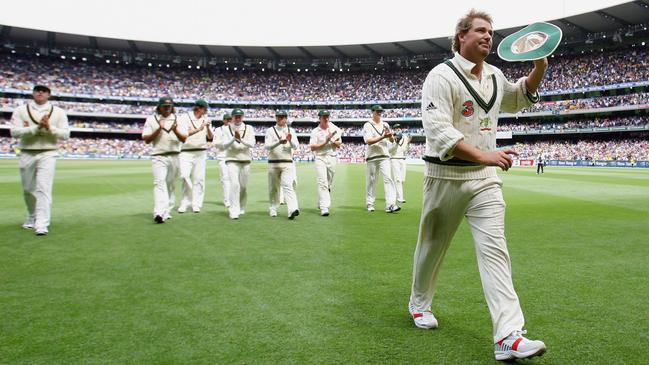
[{"xmin": 421, "ymin": 53, "xmax": 539, "ymax": 177}]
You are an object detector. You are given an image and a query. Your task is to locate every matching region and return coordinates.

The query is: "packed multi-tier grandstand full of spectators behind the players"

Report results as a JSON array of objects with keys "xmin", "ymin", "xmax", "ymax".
[{"xmin": 0, "ymin": 32, "xmax": 649, "ymax": 166}]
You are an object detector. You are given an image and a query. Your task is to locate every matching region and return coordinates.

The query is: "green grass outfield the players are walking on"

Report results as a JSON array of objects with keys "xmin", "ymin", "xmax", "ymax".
[{"xmin": 0, "ymin": 160, "xmax": 649, "ymax": 364}]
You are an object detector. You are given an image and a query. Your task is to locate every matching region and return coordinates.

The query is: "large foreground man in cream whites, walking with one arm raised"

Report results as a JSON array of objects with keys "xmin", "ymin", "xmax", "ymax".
[{"xmin": 409, "ymin": 10, "xmax": 547, "ymax": 360}]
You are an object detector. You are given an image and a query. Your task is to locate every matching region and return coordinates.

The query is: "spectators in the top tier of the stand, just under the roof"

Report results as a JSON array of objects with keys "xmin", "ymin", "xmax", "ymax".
[{"xmin": 0, "ymin": 47, "xmax": 649, "ymax": 101}]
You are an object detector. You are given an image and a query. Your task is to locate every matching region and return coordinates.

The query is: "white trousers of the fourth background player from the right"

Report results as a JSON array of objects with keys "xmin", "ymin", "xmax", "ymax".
[{"xmin": 268, "ymin": 163, "xmax": 298, "ymax": 215}]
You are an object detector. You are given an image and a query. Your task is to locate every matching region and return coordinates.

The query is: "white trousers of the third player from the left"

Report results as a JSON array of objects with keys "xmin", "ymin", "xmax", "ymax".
[{"xmin": 179, "ymin": 150, "xmax": 207, "ymax": 210}]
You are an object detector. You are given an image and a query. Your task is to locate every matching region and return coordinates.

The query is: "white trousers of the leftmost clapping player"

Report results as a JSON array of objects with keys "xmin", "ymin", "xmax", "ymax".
[{"xmin": 19, "ymin": 151, "xmax": 58, "ymax": 231}]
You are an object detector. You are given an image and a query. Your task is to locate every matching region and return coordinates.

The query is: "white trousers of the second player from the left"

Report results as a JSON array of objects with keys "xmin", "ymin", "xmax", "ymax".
[{"xmin": 151, "ymin": 154, "xmax": 179, "ymax": 218}]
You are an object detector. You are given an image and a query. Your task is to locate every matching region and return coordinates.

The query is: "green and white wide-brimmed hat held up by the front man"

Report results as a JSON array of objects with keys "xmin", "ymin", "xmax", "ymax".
[{"xmin": 498, "ymin": 22, "xmax": 563, "ymax": 62}]
